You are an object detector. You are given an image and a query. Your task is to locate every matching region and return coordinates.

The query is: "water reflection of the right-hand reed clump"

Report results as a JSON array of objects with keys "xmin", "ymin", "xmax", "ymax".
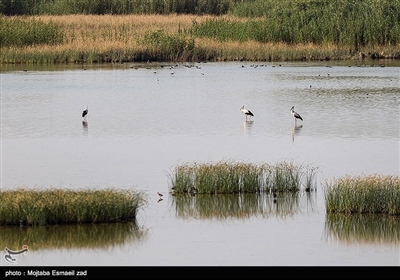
[{"xmin": 325, "ymin": 214, "xmax": 400, "ymax": 245}]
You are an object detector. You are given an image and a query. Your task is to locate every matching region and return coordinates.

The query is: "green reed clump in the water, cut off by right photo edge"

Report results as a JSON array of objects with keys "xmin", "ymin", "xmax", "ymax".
[{"xmin": 325, "ymin": 175, "xmax": 400, "ymax": 215}]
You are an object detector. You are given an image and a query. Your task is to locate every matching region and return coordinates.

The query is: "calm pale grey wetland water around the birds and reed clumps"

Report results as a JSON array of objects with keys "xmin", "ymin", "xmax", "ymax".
[{"xmin": 0, "ymin": 62, "xmax": 400, "ymax": 266}]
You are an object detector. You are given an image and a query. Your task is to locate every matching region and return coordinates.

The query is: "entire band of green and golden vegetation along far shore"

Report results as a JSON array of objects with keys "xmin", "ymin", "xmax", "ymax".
[{"xmin": 0, "ymin": 0, "xmax": 400, "ymax": 63}]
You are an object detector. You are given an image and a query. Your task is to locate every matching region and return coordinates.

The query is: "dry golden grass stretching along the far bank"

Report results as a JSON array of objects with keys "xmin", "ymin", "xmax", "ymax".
[{"xmin": 0, "ymin": 14, "xmax": 399, "ymax": 63}]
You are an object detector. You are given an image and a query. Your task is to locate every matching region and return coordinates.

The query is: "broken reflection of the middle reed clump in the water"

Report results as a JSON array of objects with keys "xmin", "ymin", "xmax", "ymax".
[{"xmin": 170, "ymin": 192, "xmax": 316, "ymax": 220}]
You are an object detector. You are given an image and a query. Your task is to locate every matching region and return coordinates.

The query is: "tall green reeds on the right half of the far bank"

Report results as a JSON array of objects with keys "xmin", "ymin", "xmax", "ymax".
[{"xmin": 191, "ymin": 0, "xmax": 400, "ymax": 48}]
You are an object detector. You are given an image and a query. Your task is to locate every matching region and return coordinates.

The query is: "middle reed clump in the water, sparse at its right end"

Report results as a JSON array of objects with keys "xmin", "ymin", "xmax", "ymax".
[{"xmin": 170, "ymin": 161, "xmax": 316, "ymax": 194}]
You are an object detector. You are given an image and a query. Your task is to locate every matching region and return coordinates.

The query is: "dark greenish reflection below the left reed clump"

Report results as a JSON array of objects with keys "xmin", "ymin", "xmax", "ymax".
[{"xmin": 0, "ymin": 222, "xmax": 148, "ymax": 250}]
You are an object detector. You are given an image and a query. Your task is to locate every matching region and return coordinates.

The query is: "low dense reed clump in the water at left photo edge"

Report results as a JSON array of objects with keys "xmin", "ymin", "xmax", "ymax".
[{"xmin": 0, "ymin": 188, "xmax": 145, "ymax": 225}]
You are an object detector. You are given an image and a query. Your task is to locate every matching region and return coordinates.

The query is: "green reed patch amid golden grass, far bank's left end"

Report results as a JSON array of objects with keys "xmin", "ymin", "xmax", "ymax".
[{"xmin": 0, "ymin": 16, "xmax": 63, "ymax": 47}]
